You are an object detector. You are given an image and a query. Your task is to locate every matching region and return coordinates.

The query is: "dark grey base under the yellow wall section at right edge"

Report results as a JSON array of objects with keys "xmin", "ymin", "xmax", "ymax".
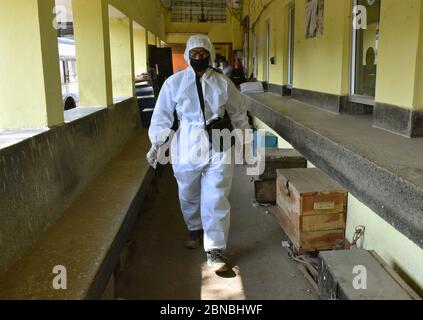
[{"xmin": 373, "ymin": 102, "xmax": 423, "ymax": 138}]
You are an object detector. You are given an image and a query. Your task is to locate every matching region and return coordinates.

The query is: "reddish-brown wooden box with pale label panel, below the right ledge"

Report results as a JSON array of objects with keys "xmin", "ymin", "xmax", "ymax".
[{"xmin": 275, "ymin": 169, "xmax": 348, "ymax": 252}]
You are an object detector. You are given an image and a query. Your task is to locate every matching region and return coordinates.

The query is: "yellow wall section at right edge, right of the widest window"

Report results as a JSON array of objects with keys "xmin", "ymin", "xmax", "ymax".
[{"xmin": 376, "ymin": 0, "xmax": 422, "ymax": 109}]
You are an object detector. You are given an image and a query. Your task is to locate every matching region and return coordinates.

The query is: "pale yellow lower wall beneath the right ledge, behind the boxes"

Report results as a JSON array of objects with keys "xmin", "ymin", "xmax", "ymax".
[{"xmin": 254, "ymin": 118, "xmax": 423, "ymax": 296}]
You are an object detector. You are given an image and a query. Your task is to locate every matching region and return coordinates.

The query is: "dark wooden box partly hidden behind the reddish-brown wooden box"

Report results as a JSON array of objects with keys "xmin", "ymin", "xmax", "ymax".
[{"xmin": 254, "ymin": 149, "xmax": 307, "ymax": 204}]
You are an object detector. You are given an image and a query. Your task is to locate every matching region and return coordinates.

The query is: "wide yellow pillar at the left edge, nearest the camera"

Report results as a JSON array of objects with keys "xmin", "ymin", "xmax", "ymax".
[{"xmin": 0, "ymin": 0, "xmax": 64, "ymax": 128}]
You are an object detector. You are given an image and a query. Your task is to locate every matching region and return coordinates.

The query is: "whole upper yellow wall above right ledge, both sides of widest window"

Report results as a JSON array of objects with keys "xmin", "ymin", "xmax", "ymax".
[{"xmin": 243, "ymin": 0, "xmax": 423, "ymax": 105}]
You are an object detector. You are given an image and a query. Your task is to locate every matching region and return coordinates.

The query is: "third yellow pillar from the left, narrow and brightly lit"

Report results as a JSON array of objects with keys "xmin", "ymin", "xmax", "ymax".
[{"xmin": 109, "ymin": 18, "xmax": 135, "ymax": 98}]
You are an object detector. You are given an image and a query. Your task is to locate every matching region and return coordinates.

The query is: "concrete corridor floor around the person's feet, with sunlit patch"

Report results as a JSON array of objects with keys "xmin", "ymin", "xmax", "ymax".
[{"xmin": 116, "ymin": 167, "xmax": 317, "ymax": 300}]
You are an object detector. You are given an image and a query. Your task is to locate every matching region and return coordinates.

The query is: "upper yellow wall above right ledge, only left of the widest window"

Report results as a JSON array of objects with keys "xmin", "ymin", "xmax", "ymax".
[{"xmin": 243, "ymin": 0, "xmax": 351, "ymax": 91}]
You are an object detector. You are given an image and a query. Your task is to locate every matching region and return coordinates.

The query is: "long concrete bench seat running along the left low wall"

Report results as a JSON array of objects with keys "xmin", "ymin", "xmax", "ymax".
[{"xmin": 0, "ymin": 131, "xmax": 154, "ymax": 300}]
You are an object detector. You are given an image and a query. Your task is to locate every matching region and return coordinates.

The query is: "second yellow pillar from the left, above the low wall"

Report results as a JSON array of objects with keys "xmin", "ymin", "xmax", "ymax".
[{"xmin": 72, "ymin": 0, "xmax": 113, "ymax": 106}]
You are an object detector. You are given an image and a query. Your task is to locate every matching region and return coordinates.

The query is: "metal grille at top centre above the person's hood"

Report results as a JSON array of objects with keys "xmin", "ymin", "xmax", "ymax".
[{"xmin": 171, "ymin": 0, "xmax": 226, "ymax": 23}]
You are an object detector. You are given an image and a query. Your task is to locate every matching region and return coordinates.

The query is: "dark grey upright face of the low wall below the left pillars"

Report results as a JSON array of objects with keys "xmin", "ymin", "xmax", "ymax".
[{"xmin": 0, "ymin": 99, "xmax": 141, "ymax": 274}]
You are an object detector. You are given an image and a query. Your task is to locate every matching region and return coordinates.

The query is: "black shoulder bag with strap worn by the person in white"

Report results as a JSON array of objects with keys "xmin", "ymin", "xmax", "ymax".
[{"xmin": 196, "ymin": 76, "xmax": 235, "ymax": 152}]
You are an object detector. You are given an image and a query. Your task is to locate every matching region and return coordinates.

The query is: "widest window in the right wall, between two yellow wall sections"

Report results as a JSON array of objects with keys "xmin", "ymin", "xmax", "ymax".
[{"xmin": 351, "ymin": 0, "xmax": 380, "ymax": 104}]
